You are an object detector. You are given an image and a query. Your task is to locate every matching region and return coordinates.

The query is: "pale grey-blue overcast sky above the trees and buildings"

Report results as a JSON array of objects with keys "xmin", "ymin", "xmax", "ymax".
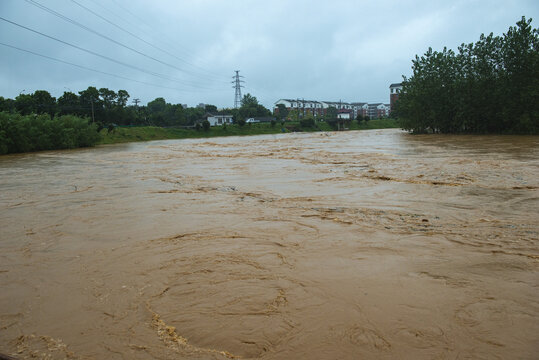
[{"xmin": 0, "ymin": 0, "xmax": 539, "ymax": 108}]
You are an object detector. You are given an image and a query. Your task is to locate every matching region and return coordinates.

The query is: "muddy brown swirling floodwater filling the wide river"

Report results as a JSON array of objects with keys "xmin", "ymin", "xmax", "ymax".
[{"xmin": 0, "ymin": 130, "xmax": 539, "ymax": 359}]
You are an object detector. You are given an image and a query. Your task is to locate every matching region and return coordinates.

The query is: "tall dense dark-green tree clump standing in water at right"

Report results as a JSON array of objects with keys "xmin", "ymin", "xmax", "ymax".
[{"xmin": 396, "ymin": 17, "xmax": 539, "ymax": 134}]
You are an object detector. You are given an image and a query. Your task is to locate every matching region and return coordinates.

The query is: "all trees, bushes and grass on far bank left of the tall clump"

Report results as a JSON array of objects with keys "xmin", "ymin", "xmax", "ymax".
[{"xmin": 0, "ymin": 87, "xmax": 398, "ymax": 154}]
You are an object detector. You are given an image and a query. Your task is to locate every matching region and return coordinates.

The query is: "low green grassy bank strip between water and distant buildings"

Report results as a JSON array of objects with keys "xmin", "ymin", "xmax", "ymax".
[{"xmin": 99, "ymin": 119, "xmax": 399, "ymax": 144}]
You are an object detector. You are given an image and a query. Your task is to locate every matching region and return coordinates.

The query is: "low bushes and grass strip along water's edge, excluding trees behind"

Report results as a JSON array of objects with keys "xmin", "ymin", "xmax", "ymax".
[{"xmin": 0, "ymin": 112, "xmax": 399, "ymax": 154}]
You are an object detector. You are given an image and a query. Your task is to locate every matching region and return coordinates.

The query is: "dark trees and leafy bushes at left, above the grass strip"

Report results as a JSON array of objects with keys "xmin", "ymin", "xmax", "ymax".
[{"xmin": 0, "ymin": 86, "xmax": 271, "ymax": 154}]
